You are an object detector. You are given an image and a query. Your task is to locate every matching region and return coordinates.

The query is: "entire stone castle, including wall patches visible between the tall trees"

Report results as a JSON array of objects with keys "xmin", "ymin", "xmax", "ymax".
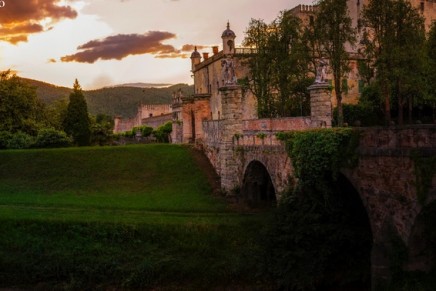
[{"xmin": 172, "ymin": 0, "xmax": 436, "ymax": 143}]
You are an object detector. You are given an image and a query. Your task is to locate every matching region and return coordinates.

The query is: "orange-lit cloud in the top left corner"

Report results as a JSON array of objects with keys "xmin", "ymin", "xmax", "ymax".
[{"xmin": 0, "ymin": 0, "xmax": 77, "ymax": 44}]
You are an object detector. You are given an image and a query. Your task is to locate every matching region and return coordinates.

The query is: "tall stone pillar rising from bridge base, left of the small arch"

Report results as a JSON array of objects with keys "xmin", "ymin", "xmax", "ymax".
[{"xmin": 219, "ymin": 85, "xmax": 242, "ymax": 194}]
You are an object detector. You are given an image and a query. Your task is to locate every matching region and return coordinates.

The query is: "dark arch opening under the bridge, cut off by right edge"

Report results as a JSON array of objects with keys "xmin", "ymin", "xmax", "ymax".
[{"xmin": 406, "ymin": 201, "xmax": 436, "ymax": 274}]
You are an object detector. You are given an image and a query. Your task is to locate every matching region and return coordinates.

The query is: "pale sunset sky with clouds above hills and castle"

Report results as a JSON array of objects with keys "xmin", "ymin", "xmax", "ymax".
[{"xmin": 0, "ymin": 0, "xmax": 313, "ymax": 89}]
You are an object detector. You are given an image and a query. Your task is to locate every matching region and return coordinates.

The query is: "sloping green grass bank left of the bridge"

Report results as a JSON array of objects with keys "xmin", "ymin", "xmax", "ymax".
[{"xmin": 0, "ymin": 145, "xmax": 270, "ymax": 290}]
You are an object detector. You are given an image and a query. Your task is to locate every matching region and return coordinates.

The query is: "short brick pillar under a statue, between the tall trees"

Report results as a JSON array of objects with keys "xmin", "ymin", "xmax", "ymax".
[{"xmin": 307, "ymin": 82, "xmax": 332, "ymax": 128}]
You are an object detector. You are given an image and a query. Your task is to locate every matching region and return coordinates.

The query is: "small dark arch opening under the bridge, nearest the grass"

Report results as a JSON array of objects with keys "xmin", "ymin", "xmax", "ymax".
[{"xmin": 241, "ymin": 161, "xmax": 277, "ymax": 207}]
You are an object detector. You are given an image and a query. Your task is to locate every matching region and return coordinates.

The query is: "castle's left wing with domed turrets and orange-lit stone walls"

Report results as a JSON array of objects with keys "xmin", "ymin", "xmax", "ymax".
[{"xmin": 172, "ymin": 23, "xmax": 257, "ymax": 143}]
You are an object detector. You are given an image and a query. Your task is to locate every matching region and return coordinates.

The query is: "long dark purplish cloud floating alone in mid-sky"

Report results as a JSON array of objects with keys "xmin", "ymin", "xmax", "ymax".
[{"xmin": 61, "ymin": 31, "xmax": 183, "ymax": 63}]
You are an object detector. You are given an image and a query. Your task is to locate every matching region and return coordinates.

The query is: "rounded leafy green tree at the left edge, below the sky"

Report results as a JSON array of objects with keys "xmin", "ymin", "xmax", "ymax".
[{"xmin": 0, "ymin": 70, "xmax": 43, "ymax": 135}]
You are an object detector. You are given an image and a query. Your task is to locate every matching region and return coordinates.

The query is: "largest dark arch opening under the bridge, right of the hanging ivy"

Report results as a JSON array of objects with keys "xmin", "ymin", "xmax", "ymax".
[{"xmin": 323, "ymin": 173, "xmax": 373, "ymax": 291}]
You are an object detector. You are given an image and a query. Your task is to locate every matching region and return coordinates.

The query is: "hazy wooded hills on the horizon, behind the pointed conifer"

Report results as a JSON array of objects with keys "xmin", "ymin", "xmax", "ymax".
[{"xmin": 22, "ymin": 78, "xmax": 194, "ymax": 118}]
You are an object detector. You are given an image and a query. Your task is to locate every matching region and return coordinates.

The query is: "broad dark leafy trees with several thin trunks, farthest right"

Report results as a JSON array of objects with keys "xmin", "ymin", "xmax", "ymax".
[{"xmin": 362, "ymin": 0, "xmax": 425, "ymax": 124}]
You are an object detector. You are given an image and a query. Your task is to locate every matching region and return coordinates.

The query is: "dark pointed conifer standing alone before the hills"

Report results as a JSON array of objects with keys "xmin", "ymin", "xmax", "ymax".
[{"xmin": 63, "ymin": 79, "xmax": 91, "ymax": 146}]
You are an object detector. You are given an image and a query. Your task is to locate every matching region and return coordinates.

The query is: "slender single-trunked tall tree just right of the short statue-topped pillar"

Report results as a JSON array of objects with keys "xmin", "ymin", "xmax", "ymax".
[{"xmin": 315, "ymin": 0, "xmax": 356, "ymax": 126}]
